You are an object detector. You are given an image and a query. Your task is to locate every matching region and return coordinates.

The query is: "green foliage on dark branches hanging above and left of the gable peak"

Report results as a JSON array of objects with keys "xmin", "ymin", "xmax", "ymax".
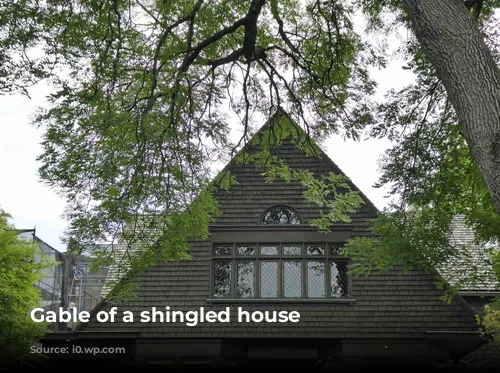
[{"xmin": 0, "ymin": 0, "xmax": 378, "ymax": 300}]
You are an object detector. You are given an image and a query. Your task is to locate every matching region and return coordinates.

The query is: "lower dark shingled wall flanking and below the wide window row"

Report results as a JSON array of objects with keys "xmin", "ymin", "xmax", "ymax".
[{"xmin": 83, "ymin": 247, "xmax": 477, "ymax": 338}]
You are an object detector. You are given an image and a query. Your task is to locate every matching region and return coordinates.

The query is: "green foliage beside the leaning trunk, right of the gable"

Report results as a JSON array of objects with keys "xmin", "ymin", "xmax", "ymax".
[{"xmin": 344, "ymin": 1, "xmax": 500, "ymax": 338}]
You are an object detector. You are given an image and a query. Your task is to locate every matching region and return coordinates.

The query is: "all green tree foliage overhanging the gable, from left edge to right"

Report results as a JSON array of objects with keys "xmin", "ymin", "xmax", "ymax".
[{"xmin": 0, "ymin": 0, "xmax": 500, "ymax": 340}]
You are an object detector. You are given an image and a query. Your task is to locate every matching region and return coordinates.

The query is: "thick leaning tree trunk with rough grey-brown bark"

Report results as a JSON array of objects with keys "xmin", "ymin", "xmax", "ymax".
[{"xmin": 403, "ymin": 0, "xmax": 500, "ymax": 214}]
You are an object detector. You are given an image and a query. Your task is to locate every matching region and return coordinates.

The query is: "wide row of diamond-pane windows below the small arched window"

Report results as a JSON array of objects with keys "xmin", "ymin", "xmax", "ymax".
[{"xmin": 211, "ymin": 241, "xmax": 353, "ymax": 302}]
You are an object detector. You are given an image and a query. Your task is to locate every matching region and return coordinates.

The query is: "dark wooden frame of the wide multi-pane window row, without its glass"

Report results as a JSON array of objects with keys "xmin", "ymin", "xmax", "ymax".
[{"xmin": 207, "ymin": 241, "xmax": 355, "ymax": 303}]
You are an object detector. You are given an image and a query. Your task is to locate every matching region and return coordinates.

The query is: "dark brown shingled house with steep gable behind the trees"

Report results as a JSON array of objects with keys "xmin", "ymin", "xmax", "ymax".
[{"xmin": 40, "ymin": 113, "xmax": 500, "ymax": 367}]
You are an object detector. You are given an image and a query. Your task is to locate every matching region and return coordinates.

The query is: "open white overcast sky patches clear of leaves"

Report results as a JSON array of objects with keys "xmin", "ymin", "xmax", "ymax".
[{"xmin": 0, "ymin": 32, "xmax": 412, "ymax": 251}]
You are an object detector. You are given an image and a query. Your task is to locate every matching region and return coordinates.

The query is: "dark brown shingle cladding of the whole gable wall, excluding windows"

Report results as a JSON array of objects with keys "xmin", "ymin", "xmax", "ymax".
[{"xmin": 81, "ymin": 131, "xmax": 477, "ymax": 338}]
